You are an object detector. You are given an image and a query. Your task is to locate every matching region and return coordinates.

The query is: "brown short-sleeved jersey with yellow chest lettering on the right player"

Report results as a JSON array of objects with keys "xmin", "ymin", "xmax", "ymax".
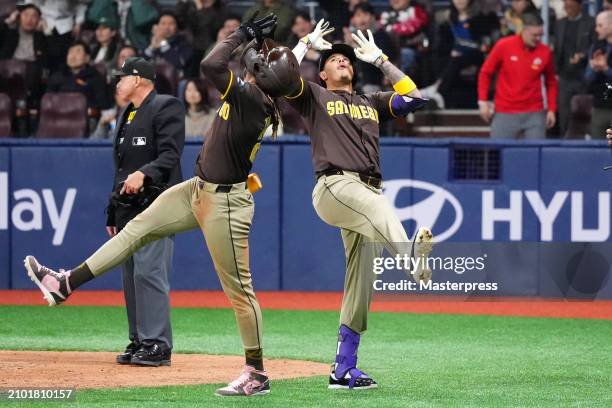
[{"xmin": 285, "ymin": 79, "xmax": 395, "ymax": 177}]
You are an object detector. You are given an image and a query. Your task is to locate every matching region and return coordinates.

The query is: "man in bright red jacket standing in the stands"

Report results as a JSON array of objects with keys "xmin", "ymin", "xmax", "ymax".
[{"xmin": 478, "ymin": 13, "xmax": 558, "ymax": 139}]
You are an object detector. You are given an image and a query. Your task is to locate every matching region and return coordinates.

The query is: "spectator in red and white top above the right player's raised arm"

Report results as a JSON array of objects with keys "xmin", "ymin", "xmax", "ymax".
[{"xmin": 380, "ymin": 0, "xmax": 429, "ymax": 72}]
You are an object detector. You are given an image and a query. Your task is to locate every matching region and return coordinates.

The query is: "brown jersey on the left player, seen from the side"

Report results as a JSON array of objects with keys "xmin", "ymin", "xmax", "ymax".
[{"xmin": 195, "ymin": 33, "xmax": 274, "ymax": 184}]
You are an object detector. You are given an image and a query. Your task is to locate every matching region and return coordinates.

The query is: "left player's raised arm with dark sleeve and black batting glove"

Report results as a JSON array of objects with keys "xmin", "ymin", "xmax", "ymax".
[{"xmin": 200, "ymin": 14, "xmax": 276, "ymax": 95}]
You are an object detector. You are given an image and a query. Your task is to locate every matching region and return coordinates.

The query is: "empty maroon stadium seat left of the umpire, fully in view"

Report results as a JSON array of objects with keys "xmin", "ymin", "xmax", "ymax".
[{"xmin": 36, "ymin": 92, "xmax": 87, "ymax": 138}]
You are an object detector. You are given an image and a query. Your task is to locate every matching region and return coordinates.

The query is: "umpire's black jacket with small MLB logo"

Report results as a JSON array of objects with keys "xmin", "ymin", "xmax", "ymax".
[{"xmin": 106, "ymin": 91, "xmax": 185, "ymax": 229}]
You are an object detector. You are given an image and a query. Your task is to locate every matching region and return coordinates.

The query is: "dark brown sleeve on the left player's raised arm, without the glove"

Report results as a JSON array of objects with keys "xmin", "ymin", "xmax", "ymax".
[{"xmin": 200, "ymin": 30, "xmax": 245, "ymax": 95}]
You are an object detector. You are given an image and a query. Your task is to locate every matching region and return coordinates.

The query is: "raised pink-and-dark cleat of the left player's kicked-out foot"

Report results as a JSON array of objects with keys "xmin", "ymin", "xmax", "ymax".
[{"xmin": 23, "ymin": 255, "xmax": 72, "ymax": 306}]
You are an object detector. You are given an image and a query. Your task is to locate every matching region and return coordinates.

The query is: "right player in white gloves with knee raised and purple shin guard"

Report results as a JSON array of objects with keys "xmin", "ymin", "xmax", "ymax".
[{"xmin": 286, "ymin": 22, "xmax": 433, "ymax": 389}]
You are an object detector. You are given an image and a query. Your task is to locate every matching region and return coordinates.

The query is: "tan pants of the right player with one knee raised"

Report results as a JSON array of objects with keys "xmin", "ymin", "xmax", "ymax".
[{"xmin": 312, "ymin": 172, "xmax": 410, "ymax": 333}]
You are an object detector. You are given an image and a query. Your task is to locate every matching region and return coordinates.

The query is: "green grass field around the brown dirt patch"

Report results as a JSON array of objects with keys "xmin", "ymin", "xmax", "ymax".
[{"xmin": 0, "ymin": 306, "xmax": 612, "ymax": 408}]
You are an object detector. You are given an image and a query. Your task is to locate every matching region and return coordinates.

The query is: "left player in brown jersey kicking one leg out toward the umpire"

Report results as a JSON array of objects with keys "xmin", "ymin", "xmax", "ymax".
[{"xmin": 20, "ymin": 15, "xmax": 284, "ymax": 396}]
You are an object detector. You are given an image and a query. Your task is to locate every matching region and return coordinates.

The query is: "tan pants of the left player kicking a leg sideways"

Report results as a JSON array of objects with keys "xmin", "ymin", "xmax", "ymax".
[{"xmin": 85, "ymin": 177, "xmax": 262, "ymax": 350}]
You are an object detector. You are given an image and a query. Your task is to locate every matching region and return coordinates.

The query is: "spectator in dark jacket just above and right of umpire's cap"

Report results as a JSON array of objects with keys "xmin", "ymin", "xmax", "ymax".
[{"xmin": 144, "ymin": 12, "xmax": 191, "ymax": 76}]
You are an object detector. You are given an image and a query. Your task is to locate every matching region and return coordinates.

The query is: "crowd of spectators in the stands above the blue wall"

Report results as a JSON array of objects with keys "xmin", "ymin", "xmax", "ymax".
[{"xmin": 0, "ymin": 0, "xmax": 612, "ymax": 139}]
